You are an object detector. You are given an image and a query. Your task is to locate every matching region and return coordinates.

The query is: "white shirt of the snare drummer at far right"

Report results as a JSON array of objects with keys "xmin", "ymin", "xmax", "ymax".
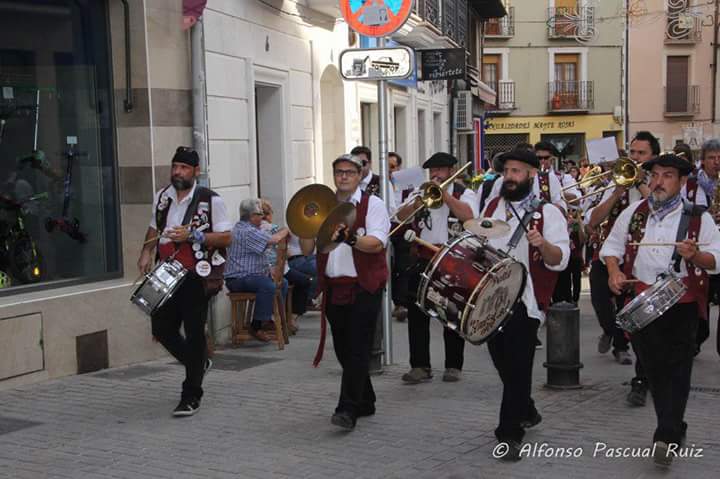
[{"xmin": 600, "ymin": 201, "xmax": 720, "ymax": 284}]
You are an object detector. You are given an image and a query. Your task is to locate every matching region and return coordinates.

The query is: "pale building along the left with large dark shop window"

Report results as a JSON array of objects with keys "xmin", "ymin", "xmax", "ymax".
[{"xmin": 0, "ymin": 0, "xmax": 500, "ymax": 388}]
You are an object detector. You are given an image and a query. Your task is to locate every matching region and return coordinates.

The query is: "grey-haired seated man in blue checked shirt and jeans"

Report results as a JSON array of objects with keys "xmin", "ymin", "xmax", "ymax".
[{"xmin": 225, "ymin": 199, "xmax": 288, "ymax": 342}]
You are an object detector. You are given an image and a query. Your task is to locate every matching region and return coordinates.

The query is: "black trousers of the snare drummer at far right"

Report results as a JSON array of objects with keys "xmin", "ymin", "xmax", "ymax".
[{"xmin": 632, "ymin": 303, "xmax": 698, "ymax": 443}]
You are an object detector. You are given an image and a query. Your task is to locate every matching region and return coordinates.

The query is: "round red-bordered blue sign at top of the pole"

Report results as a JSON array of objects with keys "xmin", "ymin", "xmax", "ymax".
[{"xmin": 340, "ymin": 0, "xmax": 413, "ymax": 37}]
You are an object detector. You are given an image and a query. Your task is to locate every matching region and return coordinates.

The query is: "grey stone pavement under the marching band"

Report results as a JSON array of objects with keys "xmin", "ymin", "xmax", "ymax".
[{"xmin": 0, "ymin": 297, "xmax": 720, "ymax": 479}]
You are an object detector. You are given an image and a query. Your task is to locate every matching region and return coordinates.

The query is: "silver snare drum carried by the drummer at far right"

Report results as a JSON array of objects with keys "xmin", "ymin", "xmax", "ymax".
[{"xmin": 615, "ymin": 273, "xmax": 687, "ymax": 333}]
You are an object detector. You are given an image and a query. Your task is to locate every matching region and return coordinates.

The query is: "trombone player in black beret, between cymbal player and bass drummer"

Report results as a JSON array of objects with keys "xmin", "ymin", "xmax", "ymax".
[{"xmin": 398, "ymin": 152, "xmax": 477, "ymax": 384}]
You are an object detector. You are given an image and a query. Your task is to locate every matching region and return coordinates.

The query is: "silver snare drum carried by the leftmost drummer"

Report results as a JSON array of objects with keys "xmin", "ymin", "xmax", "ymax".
[{"xmin": 130, "ymin": 260, "xmax": 188, "ymax": 316}]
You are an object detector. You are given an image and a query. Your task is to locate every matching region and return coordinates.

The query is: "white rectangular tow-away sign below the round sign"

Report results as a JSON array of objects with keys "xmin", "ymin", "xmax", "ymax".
[{"xmin": 340, "ymin": 47, "xmax": 415, "ymax": 80}]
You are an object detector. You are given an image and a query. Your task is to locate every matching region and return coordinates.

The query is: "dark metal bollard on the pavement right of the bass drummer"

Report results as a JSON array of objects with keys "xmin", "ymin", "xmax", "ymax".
[{"xmin": 543, "ymin": 302, "xmax": 583, "ymax": 389}]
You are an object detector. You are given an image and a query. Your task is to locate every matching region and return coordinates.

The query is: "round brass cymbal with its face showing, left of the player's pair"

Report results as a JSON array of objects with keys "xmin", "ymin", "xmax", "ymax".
[{"xmin": 285, "ymin": 184, "xmax": 338, "ymax": 239}]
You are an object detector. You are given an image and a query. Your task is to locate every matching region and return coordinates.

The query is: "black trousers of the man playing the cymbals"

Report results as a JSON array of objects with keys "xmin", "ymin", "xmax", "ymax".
[{"xmin": 325, "ymin": 290, "xmax": 382, "ymax": 417}]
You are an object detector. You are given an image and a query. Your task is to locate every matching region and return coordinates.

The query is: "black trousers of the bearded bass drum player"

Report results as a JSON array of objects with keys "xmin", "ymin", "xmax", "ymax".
[{"xmin": 488, "ymin": 303, "xmax": 540, "ymax": 442}]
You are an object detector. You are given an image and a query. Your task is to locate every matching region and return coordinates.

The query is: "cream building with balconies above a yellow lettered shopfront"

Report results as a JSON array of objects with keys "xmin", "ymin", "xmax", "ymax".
[{"xmin": 482, "ymin": 0, "xmax": 624, "ymax": 160}]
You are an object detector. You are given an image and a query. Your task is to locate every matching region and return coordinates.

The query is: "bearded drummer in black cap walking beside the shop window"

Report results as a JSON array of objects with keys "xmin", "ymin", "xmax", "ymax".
[{"xmin": 138, "ymin": 146, "xmax": 233, "ymax": 417}]
